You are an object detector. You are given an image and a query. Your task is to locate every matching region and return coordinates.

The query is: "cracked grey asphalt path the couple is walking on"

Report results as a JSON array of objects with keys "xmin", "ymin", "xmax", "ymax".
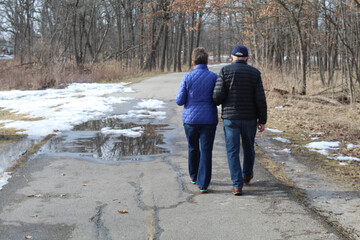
[{"xmin": 0, "ymin": 64, "xmax": 343, "ymax": 240}]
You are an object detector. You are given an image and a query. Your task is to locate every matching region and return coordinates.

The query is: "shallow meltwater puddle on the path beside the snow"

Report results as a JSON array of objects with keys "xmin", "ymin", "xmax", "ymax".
[{"xmin": 45, "ymin": 118, "xmax": 171, "ymax": 162}]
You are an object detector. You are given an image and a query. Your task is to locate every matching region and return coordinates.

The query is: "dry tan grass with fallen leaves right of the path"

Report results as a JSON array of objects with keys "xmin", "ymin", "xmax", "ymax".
[{"xmin": 264, "ymin": 68, "xmax": 360, "ymax": 190}]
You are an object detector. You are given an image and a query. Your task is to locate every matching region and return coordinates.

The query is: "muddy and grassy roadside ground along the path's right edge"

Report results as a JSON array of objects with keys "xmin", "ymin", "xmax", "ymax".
[{"xmin": 257, "ymin": 90, "xmax": 360, "ymax": 239}]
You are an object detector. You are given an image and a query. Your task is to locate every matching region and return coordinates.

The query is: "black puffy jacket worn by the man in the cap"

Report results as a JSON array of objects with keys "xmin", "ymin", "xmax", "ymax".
[{"xmin": 213, "ymin": 60, "xmax": 267, "ymax": 124}]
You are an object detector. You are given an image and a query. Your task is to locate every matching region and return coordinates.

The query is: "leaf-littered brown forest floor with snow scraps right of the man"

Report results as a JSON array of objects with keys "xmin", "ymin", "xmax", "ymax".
[{"xmin": 267, "ymin": 91, "xmax": 360, "ymax": 190}]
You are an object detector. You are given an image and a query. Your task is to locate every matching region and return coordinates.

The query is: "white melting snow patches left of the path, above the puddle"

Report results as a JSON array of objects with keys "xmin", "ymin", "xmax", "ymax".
[{"xmin": 0, "ymin": 83, "xmax": 166, "ymax": 190}]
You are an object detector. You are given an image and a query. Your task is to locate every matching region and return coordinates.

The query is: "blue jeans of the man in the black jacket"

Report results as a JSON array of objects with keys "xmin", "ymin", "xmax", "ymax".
[{"xmin": 223, "ymin": 119, "xmax": 257, "ymax": 188}]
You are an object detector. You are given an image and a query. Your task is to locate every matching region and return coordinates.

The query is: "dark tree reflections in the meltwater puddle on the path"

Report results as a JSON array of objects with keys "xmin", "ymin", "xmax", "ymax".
[{"xmin": 49, "ymin": 118, "xmax": 168, "ymax": 161}]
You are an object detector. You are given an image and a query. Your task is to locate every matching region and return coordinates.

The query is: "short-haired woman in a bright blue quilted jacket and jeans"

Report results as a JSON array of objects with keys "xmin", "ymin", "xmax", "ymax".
[{"xmin": 175, "ymin": 47, "xmax": 218, "ymax": 193}]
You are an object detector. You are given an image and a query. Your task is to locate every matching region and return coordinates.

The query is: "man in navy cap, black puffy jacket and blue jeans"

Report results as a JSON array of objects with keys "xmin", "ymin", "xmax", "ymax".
[{"xmin": 213, "ymin": 45, "xmax": 267, "ymax": 195}]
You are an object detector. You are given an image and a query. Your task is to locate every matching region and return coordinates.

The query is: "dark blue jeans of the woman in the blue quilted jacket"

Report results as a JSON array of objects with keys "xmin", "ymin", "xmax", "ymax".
[{"xmin": 184, "ymin": 123, "xmax": 216, "ymax": 188}]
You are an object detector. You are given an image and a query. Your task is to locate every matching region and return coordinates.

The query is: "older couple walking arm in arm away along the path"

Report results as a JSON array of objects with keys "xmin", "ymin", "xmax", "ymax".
[{"xmin": 176, "ymin": 45, "xmax": 267, "ymax": 195}]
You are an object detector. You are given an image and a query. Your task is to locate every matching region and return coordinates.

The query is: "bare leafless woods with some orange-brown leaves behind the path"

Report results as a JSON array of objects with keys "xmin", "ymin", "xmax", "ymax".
[{"xmin": 0, "ymin": 0, "xmax": 360, "ymax": 102}]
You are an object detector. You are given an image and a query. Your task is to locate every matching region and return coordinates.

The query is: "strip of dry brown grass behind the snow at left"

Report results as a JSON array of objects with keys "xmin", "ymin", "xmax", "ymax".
[{"xmin": 0, "ymin": 60, "xmax": 159, "ymax": 90}]
